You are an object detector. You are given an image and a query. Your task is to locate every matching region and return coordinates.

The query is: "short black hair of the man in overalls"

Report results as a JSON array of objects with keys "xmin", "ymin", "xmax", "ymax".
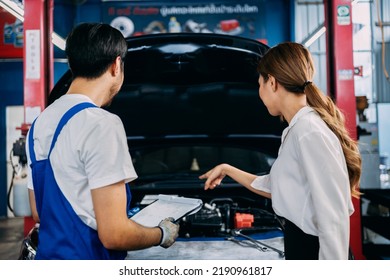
[{"xmin": 65, "ymin": 23, "xmax": 127, "ymax": 79}]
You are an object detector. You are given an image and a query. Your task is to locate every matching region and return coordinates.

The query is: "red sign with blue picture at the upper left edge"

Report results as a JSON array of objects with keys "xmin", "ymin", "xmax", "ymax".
[{"xmin": 0, "ymin": 8, "xmax": 24, "ymax": 58}]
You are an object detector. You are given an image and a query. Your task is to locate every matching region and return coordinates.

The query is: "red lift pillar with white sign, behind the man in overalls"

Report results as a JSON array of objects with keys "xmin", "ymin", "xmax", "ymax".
[{"xmin": 22, "ymin": 0, "xmax": 54, "ymax": 235}]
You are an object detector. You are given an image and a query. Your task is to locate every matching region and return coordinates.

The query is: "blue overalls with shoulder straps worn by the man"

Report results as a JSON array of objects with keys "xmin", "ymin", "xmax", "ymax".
[{"xmin": 29, "ymin": 102, "xmax": 131, "ymax": 260}]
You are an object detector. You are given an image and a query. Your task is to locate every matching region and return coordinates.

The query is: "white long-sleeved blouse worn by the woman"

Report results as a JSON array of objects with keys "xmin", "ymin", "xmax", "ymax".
[{"xmin": 252, "ymin": 107, "xmax": 354, "ymax": 259}]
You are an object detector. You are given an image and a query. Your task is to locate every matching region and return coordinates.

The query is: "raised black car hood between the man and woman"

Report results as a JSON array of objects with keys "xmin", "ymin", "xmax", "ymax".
[{"xmin": 49, "ymin": 33, "xmax": 285, "ymax": 139}]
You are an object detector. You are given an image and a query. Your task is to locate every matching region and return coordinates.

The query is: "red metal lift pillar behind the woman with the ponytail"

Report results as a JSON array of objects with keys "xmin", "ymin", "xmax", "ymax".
[{"xmin": 324, "ymin": 0, "xmax": 364, "ymax": 259}]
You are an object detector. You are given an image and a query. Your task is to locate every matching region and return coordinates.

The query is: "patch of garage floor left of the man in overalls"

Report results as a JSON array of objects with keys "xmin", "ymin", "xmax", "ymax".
[{"xmin": 0, "ymin": 218, "xmax": 24, "ymax": 260}]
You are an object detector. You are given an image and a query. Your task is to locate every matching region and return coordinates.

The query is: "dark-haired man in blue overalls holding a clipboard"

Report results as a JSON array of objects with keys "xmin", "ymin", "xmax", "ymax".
[{"xmin": 27, "ymin": 23, "xmax": 179, "ymax": 259}]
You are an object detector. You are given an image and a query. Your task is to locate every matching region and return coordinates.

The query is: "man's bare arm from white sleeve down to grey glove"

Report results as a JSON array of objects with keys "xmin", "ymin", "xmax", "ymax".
[{"xmin": 92, "ymin": 181, "xmax": 167, "ymax": 251}]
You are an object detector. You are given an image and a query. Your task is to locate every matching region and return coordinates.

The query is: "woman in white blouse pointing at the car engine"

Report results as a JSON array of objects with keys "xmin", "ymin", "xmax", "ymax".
[{"xmin": 200, "ymin": 42, "xmax": 361, "ymax": 260}]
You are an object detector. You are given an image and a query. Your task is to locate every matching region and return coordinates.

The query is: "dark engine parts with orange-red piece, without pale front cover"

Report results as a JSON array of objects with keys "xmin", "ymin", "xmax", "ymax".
[{"xmin": 133, "ymin": 188, "xmax": 283, "ymax": 238}]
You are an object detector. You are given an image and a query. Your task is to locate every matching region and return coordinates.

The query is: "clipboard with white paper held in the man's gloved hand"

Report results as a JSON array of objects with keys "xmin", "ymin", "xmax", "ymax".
[{"xmin": 130, "ymin": 194, "xmax": 203, "ymax": 227}]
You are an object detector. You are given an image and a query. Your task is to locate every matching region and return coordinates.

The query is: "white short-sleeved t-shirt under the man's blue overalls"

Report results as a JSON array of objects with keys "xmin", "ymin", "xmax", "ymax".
[{"xmin": 26, "ymin": 94, "xmax": 137, "ymax": 229}]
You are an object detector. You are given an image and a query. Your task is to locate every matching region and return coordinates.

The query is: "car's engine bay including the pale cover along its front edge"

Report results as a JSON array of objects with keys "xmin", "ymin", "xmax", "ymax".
[{"xmin": 128, "ymin": 191, "xmax": 284, "ymax": 259}]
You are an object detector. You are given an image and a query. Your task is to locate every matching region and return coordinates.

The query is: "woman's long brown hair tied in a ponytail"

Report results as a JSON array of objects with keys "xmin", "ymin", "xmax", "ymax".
[{"xmin": 258, "ymin": 42, "xmax": 362, "ymax": 197}]
